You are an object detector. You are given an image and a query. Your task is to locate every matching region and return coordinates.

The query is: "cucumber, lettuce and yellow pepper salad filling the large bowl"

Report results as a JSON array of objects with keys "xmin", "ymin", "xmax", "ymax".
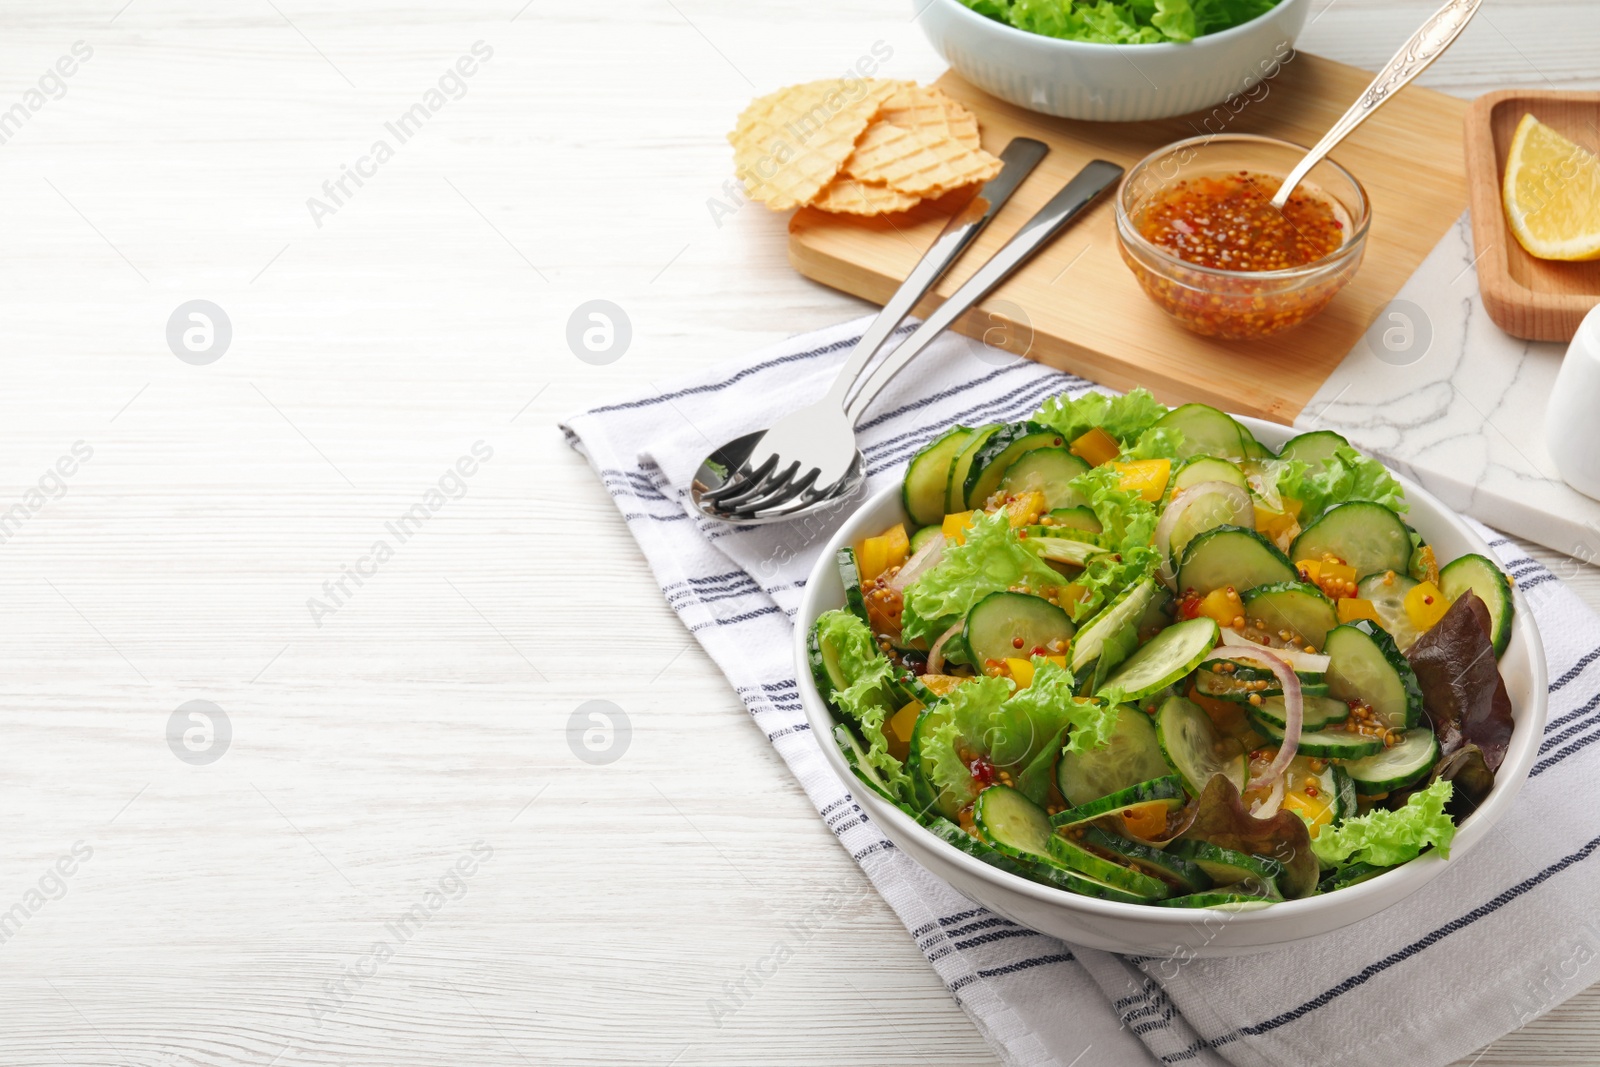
[{"xmin": 808, "ymin": 390, "xmax": 1514, "ymax": 909}]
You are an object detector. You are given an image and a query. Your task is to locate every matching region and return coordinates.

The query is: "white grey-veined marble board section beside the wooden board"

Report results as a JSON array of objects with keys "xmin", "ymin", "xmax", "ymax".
[{"xmin": 1296, "ymin": 214, "xmax": 1600, "ymax": 563}]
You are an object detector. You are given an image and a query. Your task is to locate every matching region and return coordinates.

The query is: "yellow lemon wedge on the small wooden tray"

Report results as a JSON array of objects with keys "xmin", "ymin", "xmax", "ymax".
[{"xmin": 1502, "ymin": 115, "xmax": 1600, "ymax": 261}]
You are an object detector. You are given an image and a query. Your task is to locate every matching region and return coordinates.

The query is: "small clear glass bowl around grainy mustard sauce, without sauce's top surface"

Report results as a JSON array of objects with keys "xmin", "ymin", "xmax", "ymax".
[{"xmin": 1117, "ymin": 133, "xmax": 1371, "ymax": 341}]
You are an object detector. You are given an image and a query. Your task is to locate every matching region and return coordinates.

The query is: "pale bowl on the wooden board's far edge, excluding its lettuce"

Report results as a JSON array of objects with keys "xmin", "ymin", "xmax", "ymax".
[{"xmin": 912, "ymin": 0, "xmax": 1310, "ymax": 122}]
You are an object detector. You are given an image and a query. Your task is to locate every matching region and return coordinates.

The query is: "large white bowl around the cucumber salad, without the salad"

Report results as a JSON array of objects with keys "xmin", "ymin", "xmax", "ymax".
[{"xmin": 795, "ymin": 418, "xmax": 1547, "ymax": 958}]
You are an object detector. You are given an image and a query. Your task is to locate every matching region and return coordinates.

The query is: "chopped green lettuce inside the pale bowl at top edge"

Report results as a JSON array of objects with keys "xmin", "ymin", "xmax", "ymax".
[{"xmin": 962, "ymin": 0, "xmax": 1278, "ymax": 45}]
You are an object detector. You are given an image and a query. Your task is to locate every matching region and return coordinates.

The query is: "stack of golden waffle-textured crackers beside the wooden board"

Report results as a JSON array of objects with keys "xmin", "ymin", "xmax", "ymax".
[{"xmin": 728, "ymin": 78, "xmax": 1000, "ymax": 214}]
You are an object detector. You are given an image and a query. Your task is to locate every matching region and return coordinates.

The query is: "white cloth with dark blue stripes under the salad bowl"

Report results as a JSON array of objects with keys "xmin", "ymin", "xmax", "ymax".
[{"xmin": 563, "ymin": 322, "xmax": 1600, "ymax": 1067}]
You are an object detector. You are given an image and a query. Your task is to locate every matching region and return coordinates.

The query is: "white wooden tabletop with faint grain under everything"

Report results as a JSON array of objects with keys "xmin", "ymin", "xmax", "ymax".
[{"xmin": 0, "ymin": 0, "xmax": 1600, "ymax": 1067}]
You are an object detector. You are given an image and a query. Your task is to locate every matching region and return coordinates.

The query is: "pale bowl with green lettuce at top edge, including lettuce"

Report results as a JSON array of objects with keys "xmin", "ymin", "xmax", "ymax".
[{"xmin": 914, "ymin": 0, "xmax": 1310, "ymax": 121}]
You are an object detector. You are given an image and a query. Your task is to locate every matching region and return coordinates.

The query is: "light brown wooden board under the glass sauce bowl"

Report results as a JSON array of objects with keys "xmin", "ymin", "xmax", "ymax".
[{"xmin": 789, "ymin": 53, "xmax": 1467, "ymax": 422}]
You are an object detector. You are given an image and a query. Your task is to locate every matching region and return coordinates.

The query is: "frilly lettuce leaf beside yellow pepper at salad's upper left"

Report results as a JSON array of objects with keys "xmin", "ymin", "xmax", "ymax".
[{"xmin": 901, "ymin": 512, "xmax": 1067, "ymax": 641}]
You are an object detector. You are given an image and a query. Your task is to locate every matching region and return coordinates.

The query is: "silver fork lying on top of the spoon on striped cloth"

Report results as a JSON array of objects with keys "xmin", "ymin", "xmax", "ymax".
[{"xmin": 691, "ymin": 138, "xmax": 1050, "ymax": 518}]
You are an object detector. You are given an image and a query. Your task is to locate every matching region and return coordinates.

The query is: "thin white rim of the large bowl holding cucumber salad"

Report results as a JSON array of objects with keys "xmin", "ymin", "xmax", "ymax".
[{"xmin": 794, "ymin": 414, "xmax": 1549, "ymax": 936}]
